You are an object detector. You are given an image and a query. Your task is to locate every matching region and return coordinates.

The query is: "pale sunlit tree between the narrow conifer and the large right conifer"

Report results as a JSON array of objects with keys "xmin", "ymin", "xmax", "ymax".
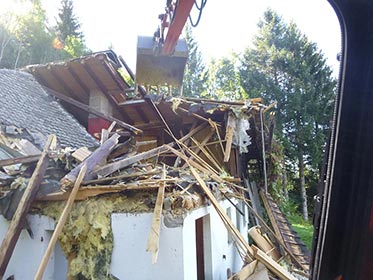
[{"xmin": 209, "ymin": 54, "xmax": 248, "ymax": 101}]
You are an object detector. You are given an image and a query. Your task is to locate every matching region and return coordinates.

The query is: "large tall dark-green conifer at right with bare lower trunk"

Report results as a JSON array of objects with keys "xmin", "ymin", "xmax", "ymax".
[{"xmin": 240, "ymin": 10, "xmax": 336, "ymax": 220}]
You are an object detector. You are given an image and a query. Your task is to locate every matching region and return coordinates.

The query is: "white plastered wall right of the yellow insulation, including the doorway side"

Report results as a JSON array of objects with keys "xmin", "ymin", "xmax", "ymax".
[{"xmin": 110, "ymin": 198, "xmax": 247, "ymax": 280}]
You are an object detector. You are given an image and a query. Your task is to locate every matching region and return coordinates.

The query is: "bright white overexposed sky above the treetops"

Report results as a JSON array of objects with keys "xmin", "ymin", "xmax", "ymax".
[{"xmin": 10, "ymin": 0, "xmax": 341, "ymax": 76}]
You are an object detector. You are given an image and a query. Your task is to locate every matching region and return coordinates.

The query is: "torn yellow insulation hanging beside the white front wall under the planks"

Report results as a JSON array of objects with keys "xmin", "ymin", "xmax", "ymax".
[{"xmin": 36, "ymin": 193, "xmax": 153, "ymax": 280}]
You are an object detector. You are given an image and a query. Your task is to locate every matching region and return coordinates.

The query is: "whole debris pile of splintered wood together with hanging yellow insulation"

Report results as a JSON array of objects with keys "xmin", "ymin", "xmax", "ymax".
[{"xmin": 0, "ymin": 99, "xmax": 304, "ymax": 279}]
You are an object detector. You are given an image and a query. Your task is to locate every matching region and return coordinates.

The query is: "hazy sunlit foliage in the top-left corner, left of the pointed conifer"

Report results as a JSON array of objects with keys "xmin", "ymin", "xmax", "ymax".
[{"xmin": 0, "ymin": 0, "xmax": 88, "ymax": 69}]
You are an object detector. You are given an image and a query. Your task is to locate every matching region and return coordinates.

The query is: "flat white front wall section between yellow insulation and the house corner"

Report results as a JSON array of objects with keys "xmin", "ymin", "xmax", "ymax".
[{"xmin": 110, "ymin": 213, "xmax": 183, "ymax": 280}]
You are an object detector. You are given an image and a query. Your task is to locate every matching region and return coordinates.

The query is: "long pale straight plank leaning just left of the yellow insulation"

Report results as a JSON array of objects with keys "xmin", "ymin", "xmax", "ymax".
[{"xmin": 34, "ymin": 165, "xmax": 87, "ymax": 280}]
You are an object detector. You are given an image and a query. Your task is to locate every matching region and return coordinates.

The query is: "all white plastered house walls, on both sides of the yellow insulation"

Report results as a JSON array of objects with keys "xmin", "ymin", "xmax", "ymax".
[{"xmin": 0, "ymin": 201, "xmax": 247, "ymax": 280}]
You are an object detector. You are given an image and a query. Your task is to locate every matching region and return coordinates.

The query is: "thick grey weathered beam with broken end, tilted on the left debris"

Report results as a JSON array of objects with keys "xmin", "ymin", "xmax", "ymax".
[{"xmin": 60, "ymin": 133, "xmax": 120, "ymax": 188}]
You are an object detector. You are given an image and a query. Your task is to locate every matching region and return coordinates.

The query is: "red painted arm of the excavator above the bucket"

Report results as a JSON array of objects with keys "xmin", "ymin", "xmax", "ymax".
[{"xmin": 162, "ymin": 0, "xmax": 194, "ymax": 55}]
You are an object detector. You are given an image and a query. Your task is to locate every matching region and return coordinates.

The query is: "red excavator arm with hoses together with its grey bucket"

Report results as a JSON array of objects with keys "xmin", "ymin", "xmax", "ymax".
[{"xmin": 136, "ymin": 0, "xmax": 206, "ymax": 88}]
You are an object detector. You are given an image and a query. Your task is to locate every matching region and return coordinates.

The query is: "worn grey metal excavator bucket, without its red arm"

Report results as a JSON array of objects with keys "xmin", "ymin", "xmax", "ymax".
[{"xmin": 136, "ymin": 36, "xmax": 188, "ymax": 88}]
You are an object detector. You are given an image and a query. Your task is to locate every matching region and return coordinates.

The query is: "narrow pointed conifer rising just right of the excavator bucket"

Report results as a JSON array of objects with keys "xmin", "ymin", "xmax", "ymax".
[{"xmin": 183, "ymin": 25, "xmax": 208, "ymax": 97}]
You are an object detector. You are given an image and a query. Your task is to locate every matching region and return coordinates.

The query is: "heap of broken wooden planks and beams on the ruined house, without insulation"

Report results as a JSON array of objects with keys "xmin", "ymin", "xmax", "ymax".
[{"xmin": 0, "ymin": 97, "xmax": 308, "ymax": 279}]
